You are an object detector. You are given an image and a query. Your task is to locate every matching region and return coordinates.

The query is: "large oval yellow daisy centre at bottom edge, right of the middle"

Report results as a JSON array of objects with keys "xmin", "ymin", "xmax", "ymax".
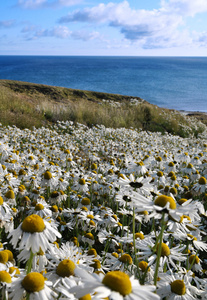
[{"xmin": 102, "ymin": 271, "xmax": 132, "ymax": 296}]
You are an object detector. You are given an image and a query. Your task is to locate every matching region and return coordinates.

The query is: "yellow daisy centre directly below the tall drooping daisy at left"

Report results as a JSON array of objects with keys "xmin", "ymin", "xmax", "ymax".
[{"xmin": 22, "ymin": 272, "xmax": 45, "ymax": 293}]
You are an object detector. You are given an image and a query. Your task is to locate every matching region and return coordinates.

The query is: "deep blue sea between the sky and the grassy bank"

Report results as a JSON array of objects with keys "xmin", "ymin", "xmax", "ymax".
[{"xmin": 0, "ymin": 56, "xmax": 207, "ymax": 112}]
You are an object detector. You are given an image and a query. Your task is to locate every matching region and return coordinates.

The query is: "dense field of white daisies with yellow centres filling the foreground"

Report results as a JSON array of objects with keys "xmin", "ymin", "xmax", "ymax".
[{"xmin": 0, "ymin": 121, "xmax": 207, "ymax": 300}]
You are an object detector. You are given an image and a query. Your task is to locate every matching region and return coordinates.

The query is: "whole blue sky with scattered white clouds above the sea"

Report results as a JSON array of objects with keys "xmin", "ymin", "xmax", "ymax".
[{"xmin": 0, "ymin": 0, "xmax": 207, "ymax": 56}]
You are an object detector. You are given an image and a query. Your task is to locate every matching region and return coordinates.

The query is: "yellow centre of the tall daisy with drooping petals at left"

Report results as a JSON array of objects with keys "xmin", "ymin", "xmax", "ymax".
[{"xmin": 22, "ymin": 215, "xmax": 45, "ymax": 233}]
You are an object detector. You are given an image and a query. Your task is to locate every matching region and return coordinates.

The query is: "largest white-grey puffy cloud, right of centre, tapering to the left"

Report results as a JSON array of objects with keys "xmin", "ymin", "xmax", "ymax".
[{"xmin": 60, "ymin": 1, "xmax": 183, "ymax": 45}]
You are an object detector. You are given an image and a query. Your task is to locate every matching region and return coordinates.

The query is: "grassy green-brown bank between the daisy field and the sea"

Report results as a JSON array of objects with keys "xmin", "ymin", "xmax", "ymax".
[{"xmin": 0, "ymin": 80, "xmax": 207, "ymax": 137}]
